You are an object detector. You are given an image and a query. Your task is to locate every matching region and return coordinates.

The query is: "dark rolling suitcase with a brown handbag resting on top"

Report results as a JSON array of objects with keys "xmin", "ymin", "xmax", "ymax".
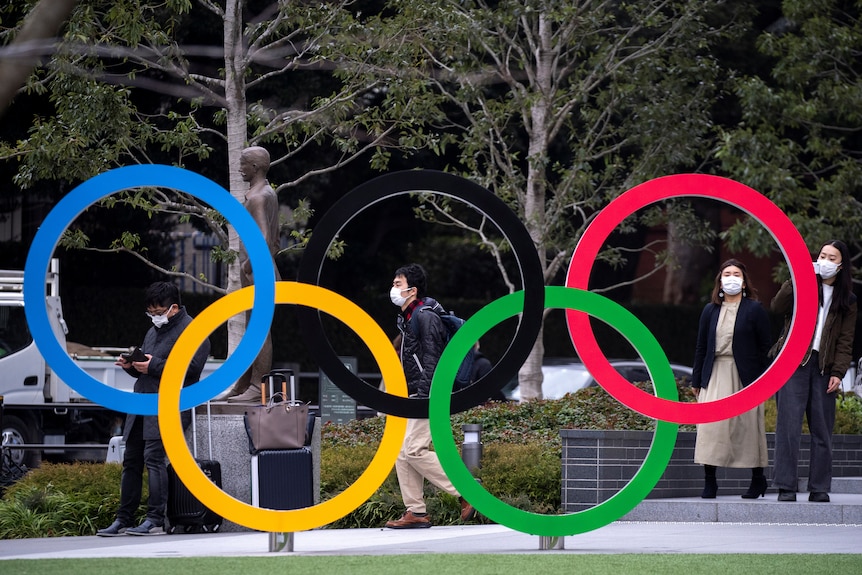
[{"xmin": 251, "ymin": 370, "xmax": 314, "ymax": 509}]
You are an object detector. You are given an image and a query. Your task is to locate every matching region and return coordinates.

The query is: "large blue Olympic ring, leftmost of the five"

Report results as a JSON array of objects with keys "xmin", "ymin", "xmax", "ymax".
[{"xmin": 24, "ymin": 165, "xmax": 275, "ymax": 415}]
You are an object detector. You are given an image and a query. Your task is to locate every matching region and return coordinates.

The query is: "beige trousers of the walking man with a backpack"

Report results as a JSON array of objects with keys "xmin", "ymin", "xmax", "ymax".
[{"xmin": 395, "ymin": 419, "xmax": 460, "ymax": 513}]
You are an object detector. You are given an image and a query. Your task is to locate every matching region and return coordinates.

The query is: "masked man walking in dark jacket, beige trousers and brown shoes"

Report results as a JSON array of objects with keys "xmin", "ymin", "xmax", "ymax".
[{"xmin": 386, "ymin": 264, "xmax": 475, "ymax": 529}]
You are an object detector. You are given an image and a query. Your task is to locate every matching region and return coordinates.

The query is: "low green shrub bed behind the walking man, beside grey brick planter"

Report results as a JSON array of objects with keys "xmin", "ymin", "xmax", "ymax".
[{"xmin": 321, "ymin": 384, "xmax": 693, "ymax": 528}]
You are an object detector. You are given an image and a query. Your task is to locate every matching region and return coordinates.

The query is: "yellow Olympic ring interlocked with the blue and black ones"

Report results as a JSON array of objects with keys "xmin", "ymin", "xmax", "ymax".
[{"xmin": 159, "ymin": 282, "xmax": 407, "ymax": 533}]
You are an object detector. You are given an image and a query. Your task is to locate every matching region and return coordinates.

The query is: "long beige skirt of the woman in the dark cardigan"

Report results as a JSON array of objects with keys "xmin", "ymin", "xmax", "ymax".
[{"xmin": 694, "ymin": 355, "xmax": 769, "ymax": 467}]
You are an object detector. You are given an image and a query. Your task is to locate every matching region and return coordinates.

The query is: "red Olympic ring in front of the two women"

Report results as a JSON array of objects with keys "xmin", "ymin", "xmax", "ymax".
[{"xmin": 566, "ymin": 174, "xmax": 817, "ymax": 424}]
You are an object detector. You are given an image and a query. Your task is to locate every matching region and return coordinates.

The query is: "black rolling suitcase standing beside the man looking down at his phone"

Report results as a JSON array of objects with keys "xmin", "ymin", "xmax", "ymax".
[{"xmin": 166, "ymin": 402, "xmax": 222, "ymax": 533}]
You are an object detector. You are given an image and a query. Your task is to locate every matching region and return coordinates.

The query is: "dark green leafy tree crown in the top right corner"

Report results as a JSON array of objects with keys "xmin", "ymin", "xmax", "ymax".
[{"xmin": 716, "ymin": 0, "xmax": 862, "ymax": 262}]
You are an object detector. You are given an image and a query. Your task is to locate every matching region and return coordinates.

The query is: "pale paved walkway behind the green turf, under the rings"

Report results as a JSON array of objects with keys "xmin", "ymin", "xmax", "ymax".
[{"xmin": 0, "ymin": 521, "xmax": 862, "ymax": 560}]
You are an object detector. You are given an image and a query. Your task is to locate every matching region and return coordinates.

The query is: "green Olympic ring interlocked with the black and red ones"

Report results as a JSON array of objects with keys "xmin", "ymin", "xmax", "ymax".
[{"xmin": 428, "ymin": 286, "xmax": 679, "ymax": 537}]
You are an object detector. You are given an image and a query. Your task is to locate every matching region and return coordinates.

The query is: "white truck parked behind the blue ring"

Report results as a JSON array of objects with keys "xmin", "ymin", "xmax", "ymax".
[{"xmin": 0, "ymin": 260, "xmax": 221, "ymax": 467}]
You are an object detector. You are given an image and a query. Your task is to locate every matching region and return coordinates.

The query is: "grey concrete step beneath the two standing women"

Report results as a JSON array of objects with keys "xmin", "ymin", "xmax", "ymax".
[{"xmin": 621, "ymin": 488, "xmax": 862, "ymax": 525}]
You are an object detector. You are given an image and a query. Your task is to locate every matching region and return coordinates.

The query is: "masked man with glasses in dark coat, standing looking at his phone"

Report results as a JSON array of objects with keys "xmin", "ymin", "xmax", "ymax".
[{"xmin": 96, "ymin": 282, "xmax": 210, "ymax": 537}]
